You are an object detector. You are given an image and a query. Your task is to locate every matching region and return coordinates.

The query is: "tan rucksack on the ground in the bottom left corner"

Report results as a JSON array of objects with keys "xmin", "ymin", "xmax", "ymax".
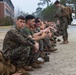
[{"xmin": 0, "ymin": 51, "xmax": 16, "ymax": 75}]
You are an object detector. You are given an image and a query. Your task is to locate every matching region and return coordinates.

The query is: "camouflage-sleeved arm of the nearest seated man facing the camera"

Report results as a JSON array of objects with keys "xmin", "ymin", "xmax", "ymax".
[{"xmin": 8, "ymin": 30, "xmax": 34, "ymax": 46}]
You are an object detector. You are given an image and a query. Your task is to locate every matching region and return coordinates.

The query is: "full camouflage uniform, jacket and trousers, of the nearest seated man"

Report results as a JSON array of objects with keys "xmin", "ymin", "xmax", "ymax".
[{"xmin": 2, "ymin": 27, "xmax": 35, "ymax": 66}]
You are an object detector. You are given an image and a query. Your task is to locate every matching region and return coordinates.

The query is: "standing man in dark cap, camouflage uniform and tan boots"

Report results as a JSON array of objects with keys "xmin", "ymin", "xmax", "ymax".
[{"xmin": 54, "ymin": 1, "xmax": 69, "ymax": 44}]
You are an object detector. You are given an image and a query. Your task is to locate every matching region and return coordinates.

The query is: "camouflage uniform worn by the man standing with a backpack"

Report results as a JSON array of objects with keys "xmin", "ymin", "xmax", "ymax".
[{"xmin": 56, "ymin": 5, "xmax": 68, "ymax": 41}]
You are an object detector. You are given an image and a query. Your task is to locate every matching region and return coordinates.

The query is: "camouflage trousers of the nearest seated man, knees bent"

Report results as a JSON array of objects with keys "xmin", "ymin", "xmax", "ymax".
[{"xmin": 10, "ymin": 46, "xmax": 30, "ymax": 66}]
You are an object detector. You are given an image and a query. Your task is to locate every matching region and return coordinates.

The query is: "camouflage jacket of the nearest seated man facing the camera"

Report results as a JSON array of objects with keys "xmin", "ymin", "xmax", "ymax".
[{"xmin": 2, "ymin": 27, "xmax": 35, "ymax": 59}]
